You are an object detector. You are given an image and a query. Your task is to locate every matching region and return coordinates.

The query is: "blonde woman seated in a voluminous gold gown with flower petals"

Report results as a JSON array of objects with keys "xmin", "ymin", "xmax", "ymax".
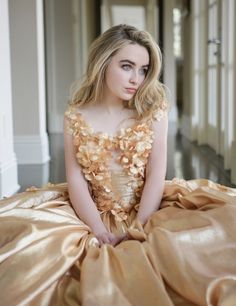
[{"xmin": 0, "ymin": 25, "xmax": 236, "ymax": 306}]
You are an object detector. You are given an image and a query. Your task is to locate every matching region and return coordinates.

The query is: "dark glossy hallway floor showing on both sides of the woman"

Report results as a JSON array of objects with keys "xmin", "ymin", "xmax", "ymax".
[{"xmin": 18, "ymin": 123, "xmax": 236, "ymax": 191}]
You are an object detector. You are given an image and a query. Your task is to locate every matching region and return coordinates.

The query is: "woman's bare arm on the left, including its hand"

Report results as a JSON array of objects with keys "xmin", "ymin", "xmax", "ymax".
[{"xmin": 64, "ymin": 117, "xmax": 124, "ymax": 245}]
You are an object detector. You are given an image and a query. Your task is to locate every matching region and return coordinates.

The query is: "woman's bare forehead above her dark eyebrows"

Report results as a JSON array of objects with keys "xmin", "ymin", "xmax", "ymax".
[{"xmin": 113, "ymin": 44, "xmax": 149, "ymax": 66}]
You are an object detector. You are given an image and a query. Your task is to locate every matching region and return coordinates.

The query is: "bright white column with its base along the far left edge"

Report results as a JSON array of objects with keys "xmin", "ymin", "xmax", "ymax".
[{"xmin": 0, "ymin": 0, "xmax": 19, "ymax": 198}]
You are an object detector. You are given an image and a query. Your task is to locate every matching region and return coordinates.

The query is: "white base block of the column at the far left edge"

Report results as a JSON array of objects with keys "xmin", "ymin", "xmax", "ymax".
[{"xmin": 0, "ymin": 155, "xmax": 20, "ymax": 199}]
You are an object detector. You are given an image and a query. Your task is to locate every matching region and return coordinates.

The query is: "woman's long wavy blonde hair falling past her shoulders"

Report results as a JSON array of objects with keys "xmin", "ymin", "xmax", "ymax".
[{"xmin": 70, "ymin": 24, "xmax": 167, "ymax": 118}]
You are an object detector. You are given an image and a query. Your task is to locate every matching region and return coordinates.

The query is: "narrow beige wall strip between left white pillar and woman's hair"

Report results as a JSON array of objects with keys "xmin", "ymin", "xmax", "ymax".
[{"xmin": 45, "ymin": 0, "xmax": 76, "ymax": 133}]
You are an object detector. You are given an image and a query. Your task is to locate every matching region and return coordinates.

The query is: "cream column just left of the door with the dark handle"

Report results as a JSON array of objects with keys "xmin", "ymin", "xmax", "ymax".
[{"xmin": 187, "ymin": 0, "xmax": 207, "ymax": 145}]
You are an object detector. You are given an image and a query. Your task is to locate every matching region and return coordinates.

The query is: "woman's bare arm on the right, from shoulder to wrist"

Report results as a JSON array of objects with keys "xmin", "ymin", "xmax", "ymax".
[{"xmin": 137, "ymin": 116, "xmax": 168, "ymax": 224}]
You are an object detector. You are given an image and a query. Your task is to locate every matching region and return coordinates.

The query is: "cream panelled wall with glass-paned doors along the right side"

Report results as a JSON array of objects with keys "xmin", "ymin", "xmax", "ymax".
[{"xmin": 181, "ymin": 0, "xmax": 236, "ymax": 183}]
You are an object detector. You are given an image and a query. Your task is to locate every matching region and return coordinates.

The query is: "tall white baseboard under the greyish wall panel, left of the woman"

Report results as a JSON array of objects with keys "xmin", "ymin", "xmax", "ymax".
[{"xmin": 14, "ymin": 133, "xmax": 50, "ymax": 165}]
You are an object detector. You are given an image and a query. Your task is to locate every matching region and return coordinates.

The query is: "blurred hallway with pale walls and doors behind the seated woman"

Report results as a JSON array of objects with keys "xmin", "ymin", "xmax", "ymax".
[{"xmin": 0, "ymin": 0, "xmax": 236, "ymax": 198}]
